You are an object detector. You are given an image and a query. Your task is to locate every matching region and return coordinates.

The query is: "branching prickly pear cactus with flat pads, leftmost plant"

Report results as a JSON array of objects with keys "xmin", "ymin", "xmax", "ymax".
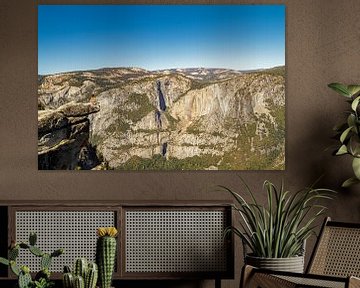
[{"xmin": 0, "ymin": 233, "xmax": 64, "ymax": 288}]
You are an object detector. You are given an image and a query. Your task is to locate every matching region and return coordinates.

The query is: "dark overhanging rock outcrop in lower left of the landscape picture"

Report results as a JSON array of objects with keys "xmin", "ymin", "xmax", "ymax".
[{"xmin": 38, "ymin": 102, "xmax": 100, "ymax": 170}]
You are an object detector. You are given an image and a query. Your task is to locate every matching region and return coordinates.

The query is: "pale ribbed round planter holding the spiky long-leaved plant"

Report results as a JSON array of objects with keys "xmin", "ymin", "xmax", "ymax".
[{"xmin": 245, "ymin": 255, "xmax": 304, "ymax": 273}]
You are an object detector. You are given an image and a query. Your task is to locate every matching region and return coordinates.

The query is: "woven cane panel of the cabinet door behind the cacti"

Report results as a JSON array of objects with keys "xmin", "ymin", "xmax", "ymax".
[{"xmin": 12, "ymin": 208, "xmax": 117, "ymax": 273}]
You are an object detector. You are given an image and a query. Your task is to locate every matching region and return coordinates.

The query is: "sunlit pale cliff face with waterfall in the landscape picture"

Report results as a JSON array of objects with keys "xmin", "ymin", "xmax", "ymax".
[{"xmin": 38, "ymin": 67, "xmax": 285, "ymax": 170}]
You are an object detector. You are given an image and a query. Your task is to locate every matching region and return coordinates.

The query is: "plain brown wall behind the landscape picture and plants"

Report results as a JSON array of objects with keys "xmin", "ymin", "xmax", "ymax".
[{"xmin": 0, "ymin": 0, "xmax": 360, "ymax": 287}]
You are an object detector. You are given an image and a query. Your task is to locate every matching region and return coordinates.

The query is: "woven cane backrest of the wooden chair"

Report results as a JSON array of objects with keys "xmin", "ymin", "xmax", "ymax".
[{"xmin": 307, "ymin": 218, "xmax": 360, "ymax": 277}]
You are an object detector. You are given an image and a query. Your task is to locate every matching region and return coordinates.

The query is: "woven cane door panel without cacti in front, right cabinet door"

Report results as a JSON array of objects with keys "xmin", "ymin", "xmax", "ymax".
[{"xmin": 123, "ymin": 207, "xmax": 230, "ymax": 277}]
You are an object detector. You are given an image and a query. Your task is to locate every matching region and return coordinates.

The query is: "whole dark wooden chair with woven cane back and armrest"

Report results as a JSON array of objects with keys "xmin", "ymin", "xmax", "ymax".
[{"xmin": 240, "ymin": 218, "xmax": 360, "ymax": 288}]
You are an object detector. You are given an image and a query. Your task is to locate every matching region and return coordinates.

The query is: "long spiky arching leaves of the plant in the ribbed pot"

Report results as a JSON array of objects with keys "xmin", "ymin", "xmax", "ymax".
[{"xmin": 220, "ymin": 179, "xmax": 334, "ymax": 258}]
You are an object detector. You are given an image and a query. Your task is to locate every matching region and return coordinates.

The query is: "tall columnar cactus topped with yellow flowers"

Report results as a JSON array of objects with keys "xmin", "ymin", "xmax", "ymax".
[{"xmin": 96, "ymin": 227, "xmax": 117, "ymax": 288}]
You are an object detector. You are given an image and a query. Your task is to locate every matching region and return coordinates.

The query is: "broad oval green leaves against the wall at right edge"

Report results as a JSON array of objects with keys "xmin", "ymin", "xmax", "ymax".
[{"xmin": 328, "ymin": 83, "xmax": 360, "ymax": 187}]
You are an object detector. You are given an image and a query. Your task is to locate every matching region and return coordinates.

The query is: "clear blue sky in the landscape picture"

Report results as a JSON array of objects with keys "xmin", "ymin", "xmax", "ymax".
[{"xmin": 38, "ymin": 5, "xmax": 285, "ymax": 74}]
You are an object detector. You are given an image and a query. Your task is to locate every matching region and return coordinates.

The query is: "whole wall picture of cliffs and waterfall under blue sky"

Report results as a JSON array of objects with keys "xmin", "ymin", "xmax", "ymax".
[{"xmin": 38, "ymin": 5, "xmax": 285, "ymax": 170}]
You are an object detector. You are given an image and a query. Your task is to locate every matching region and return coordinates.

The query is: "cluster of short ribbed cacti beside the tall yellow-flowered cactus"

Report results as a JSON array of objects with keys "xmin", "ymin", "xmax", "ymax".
[{"xmin": 63, "ymin": 258, "xmax": 98, "ymax": 288}]
